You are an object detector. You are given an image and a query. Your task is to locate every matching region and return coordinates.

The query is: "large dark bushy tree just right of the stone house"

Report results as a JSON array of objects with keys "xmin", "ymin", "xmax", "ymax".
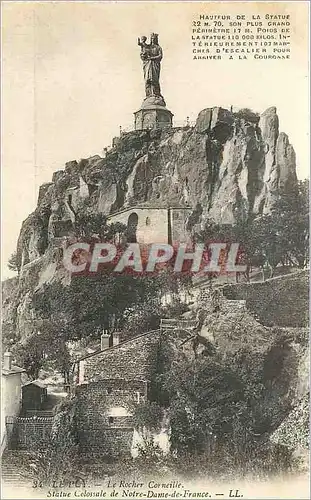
[{"xmin": 164, "ymin": 356, "xmax": 252, "ymax": 454}]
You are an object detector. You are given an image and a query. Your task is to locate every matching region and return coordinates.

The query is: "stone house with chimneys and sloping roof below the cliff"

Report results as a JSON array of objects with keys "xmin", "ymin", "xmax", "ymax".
[{"xmin": 73, "ymin": 330, "xmax": 160, "ymax": 456}]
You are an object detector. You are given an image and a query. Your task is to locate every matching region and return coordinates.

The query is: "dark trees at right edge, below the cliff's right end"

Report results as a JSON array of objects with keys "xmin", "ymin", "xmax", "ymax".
[{"xmin": 195, "ymin": 180, "xmax": 309, "ymax": 281}]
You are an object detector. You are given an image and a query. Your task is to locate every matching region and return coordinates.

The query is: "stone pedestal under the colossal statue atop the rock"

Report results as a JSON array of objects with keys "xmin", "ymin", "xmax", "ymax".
[{"xmin": 134, "ymin": 97, "xmax": 174, "ymax": 130}]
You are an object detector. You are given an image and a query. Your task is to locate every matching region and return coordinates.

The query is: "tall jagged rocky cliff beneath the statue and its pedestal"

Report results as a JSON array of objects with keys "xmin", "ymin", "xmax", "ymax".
[{"xmin": 3, "ymin": 107, "xmax": 297, "ymax": 336}]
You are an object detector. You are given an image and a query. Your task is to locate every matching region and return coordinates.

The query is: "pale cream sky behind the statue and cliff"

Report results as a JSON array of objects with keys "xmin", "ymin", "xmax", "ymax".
[{"xmin": 1, "ymin": 1, "xmax": 309, "ymax": 279}]
